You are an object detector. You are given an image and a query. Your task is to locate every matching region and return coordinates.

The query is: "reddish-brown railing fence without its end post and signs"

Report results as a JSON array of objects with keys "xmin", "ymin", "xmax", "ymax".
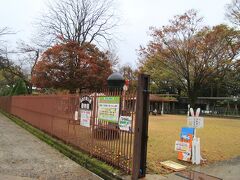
[{"xmin": 0, "ymin": 91, "xmax": 136, "ymax": 173}]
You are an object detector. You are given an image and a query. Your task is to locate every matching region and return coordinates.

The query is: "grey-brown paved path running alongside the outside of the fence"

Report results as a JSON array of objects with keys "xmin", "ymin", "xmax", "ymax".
[{"xmin": 0, "ymin": 113, "xmax": 100, "ymax": 180}]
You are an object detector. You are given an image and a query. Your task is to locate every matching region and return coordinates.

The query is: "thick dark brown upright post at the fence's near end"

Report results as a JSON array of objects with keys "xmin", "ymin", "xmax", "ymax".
[{"xmin": 132, "ymin": 74, "xmax": 150, "ymax": 180}]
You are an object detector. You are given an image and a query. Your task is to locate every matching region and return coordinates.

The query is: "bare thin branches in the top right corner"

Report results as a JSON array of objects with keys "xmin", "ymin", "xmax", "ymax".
[{"xmin": 226, "ymin": 0, "xmax": 240, "ymax": 27}]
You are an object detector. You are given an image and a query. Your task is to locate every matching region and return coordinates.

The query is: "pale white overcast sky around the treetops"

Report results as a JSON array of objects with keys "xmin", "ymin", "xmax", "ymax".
[{"xmin": 0, "ymin": 0, "xmax": 231, "ymax": 67}]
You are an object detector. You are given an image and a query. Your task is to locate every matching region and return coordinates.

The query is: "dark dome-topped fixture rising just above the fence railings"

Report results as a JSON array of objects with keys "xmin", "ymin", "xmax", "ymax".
[{"xmin": 107, "ymin": 72, "xmax": 125, "ymax": 91}]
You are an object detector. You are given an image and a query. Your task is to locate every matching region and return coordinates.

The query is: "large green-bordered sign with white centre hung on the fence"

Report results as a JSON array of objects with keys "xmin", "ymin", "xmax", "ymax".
[{"xmin": 98, "ymin": 96, "xmax": 120, "ymax": 123}]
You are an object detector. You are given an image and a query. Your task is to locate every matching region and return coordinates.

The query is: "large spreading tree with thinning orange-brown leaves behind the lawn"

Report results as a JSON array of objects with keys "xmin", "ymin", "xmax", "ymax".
[{"xmin": 140, "ymin": 10, "xmax": 240, "ymax": 106}]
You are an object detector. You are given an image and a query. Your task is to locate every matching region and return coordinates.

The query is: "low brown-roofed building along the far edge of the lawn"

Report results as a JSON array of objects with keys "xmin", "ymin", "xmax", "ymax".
[{"xmin": 127, "ymin": 94, "xmax": 240, "ymax": 117}]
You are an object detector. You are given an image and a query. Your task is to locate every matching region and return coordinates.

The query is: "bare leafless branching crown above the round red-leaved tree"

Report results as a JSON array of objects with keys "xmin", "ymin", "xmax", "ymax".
[{"xmin": 36, "ymin": 0, "xmax": 117, "ymax": 45}]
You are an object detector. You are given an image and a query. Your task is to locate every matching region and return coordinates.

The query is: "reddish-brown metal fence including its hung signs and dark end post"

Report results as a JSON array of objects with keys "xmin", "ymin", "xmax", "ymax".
[{"xmin": 0, "ymin": 73, "xmax": 149, "ymax": 177}]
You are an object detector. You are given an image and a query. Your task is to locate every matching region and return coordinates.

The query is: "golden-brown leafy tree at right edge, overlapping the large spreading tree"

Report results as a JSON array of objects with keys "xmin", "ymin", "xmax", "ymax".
[{"xmin": 199, "ymin": 25, "xmax": 240, "ymax": 96}]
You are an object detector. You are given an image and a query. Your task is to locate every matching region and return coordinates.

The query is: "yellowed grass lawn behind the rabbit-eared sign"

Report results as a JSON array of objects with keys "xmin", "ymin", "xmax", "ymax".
[{"xmin": 147, "ymin": 115, "xmax": 240, "ymax": 173}]
